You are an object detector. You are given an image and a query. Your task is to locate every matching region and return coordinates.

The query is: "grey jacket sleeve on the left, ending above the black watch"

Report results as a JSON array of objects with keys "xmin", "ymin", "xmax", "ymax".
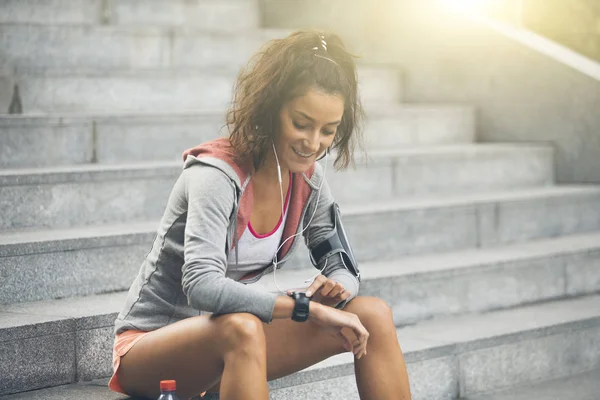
[{"xmin": 181, "ymin": 165, "xmax": 278, "ymax": 323}]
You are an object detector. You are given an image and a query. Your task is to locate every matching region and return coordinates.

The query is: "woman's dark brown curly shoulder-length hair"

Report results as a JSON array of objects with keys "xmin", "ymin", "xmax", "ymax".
[{"xmin": 227, "ymin": 30, "xmax": 364, "ymax": 170}]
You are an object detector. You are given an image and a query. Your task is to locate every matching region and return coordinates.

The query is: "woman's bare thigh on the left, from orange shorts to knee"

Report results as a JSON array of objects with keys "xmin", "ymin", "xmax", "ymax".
[{"xmin": 117, "ymin": 313, "xmax": 262, "ymax": 398}]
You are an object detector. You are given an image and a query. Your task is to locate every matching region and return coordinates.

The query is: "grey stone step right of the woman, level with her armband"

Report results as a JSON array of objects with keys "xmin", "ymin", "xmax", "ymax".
[{"xmin": 345, "ymin": 187, "xmax": 600, "ymax": 260}]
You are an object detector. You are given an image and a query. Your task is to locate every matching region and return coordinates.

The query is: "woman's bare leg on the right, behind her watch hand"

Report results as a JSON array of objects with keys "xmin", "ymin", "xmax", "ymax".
[{"xmin": 209, "ymin": 296, "xmax": 411, "ymax": 400}]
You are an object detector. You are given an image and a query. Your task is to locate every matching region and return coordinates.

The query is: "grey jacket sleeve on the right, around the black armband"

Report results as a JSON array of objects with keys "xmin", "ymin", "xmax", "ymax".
[{"xmin": 303, "ymin": 168, "xmax": 359, "ymax": 309}]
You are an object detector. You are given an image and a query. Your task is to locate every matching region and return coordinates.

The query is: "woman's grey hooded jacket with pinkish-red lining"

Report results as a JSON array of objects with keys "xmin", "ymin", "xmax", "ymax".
[{"xmin": 115, "ymin": 144, "xmax": 359, "ymax": 334}]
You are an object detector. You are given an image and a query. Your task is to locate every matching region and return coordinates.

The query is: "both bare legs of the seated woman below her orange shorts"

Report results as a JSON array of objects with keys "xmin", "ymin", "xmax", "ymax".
[{"xmin": 119, "ymin": 296, "xmax": 410, "ymax": 400}]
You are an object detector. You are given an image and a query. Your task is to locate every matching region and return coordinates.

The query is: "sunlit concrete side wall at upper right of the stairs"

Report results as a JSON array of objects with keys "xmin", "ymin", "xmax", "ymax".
[{"xmin": 263, "ymin": 0, "xmax": 600, "ymax": 183}]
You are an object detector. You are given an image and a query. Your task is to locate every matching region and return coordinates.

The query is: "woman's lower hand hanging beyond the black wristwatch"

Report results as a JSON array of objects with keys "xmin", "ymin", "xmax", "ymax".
[{"xmin": 308, "ymin": 301, "xmax": 369, "ymax": 358}]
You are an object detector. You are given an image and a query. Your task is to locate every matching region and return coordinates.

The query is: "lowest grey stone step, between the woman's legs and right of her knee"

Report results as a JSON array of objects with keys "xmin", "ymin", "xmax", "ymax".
[{"xmin": 270, "ymin": 296, "xmax": 600, "ymax": 400}]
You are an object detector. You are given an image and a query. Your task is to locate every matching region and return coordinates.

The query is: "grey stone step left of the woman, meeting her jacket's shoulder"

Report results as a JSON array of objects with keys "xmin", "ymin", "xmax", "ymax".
[{"xmin": 0, "ymin": 167, "xmax": 178, "ymax": 230}]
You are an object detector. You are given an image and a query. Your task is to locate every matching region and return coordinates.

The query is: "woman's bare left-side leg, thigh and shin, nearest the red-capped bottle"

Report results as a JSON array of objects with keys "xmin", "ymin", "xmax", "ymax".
[{"xmin": 117, "ymin": 313, "xmax": 269, "ymax": 400}]
